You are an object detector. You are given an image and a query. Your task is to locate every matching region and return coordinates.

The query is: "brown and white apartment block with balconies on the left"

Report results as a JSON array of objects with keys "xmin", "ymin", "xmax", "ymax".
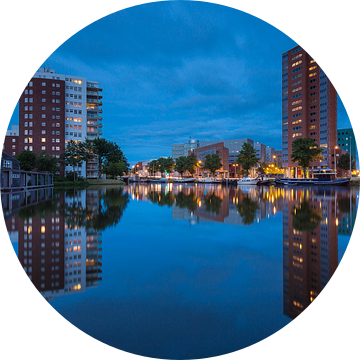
[{"xmin": 3, "ymin": 67, "xmax": 102, "ymax": 178}]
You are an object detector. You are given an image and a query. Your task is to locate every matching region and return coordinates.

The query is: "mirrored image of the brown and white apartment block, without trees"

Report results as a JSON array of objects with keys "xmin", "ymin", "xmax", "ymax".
[{"xmin": 5, "ymin": 190, "xmax": 102, "ymax": 301}]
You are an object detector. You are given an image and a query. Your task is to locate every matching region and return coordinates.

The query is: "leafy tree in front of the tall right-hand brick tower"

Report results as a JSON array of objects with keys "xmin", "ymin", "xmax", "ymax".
[{"xmin": 291, "ymin": 138, "xmax": 324, "ymax": 174}]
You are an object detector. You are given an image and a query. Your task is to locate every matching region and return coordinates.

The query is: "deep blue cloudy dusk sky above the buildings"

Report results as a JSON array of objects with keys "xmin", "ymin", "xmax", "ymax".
[{"xmin": 8, "ymin": 0, "xmax": 358, "ymax": 165}]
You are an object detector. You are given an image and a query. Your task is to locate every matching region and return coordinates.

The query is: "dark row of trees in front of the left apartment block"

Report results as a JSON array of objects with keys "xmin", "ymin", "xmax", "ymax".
[{"xmin": 15, "ymin": 138, "xmax": 129, "ymax": 180}]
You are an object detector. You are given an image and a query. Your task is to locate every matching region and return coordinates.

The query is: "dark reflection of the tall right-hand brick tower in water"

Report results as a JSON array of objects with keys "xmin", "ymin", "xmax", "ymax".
[{"xmin": 283, "ymin": 189, "xmax": 355, "ymax": 319}]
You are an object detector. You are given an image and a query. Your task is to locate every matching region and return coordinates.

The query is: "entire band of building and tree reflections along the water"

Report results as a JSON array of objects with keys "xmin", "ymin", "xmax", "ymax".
[{"xmin": 2, "ymin": 184, "xmax": 357, "ymax": 308}]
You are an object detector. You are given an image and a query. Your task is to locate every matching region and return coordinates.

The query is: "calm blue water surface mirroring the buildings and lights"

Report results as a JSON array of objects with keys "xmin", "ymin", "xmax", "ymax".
[{"xmin": 2, "ymin": 184, "xmax": 360, "ymax": 359}]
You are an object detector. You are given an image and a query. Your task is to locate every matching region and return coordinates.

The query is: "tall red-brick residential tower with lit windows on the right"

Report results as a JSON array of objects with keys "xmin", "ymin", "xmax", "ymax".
[{"xmin": 282, "ymin": 46, "xmax": 337, "ymax": 177}]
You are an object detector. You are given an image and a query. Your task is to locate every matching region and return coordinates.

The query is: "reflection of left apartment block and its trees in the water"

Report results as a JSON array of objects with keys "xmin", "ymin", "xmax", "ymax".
[{"xmin": 1, "ymin": 188, "xmax": 129, "ymax": 301}]
